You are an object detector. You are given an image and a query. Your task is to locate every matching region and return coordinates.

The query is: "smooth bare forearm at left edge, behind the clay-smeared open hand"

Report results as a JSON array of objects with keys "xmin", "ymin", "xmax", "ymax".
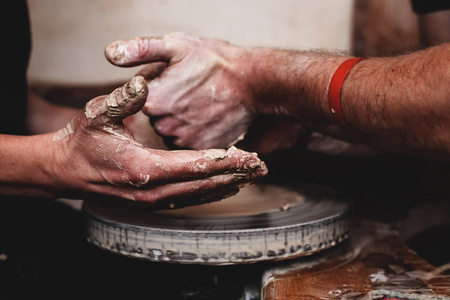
[{"xmin": 0, "ymin": 135, "xmax": 53, "ymax": 198}]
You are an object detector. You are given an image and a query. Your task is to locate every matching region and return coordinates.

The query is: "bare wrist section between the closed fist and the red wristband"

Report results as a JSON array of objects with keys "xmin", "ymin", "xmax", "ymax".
[{"xmin": 246, "ymin": 48, "xmax": 348, "ymax": 137}]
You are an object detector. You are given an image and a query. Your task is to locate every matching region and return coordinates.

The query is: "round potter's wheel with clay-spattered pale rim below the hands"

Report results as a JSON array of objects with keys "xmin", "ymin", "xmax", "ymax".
[{"xmin": 83, "ymin": 184, "xmax": 350, "ymax": 265}]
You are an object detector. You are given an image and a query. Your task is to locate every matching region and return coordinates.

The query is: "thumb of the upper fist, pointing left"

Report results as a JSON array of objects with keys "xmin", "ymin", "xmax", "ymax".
[{"xmin": 105, "ymin": 35, "xmax": 174, "ymax": 67}]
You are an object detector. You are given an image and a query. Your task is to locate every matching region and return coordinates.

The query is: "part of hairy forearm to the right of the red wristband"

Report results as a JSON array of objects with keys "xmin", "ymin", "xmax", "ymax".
[{"xmin": 342, "ymin": 44, "xmax": 450, "ymax": 160}]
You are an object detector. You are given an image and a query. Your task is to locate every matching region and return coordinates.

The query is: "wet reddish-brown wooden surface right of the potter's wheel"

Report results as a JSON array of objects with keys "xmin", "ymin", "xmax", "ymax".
[{"xmin": 262, "ymin": 221, "xmax": 450, "ymax": 300}]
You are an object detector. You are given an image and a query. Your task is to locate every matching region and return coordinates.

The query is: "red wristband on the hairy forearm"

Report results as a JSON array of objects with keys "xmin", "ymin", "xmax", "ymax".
[{"xmin": 328, "ymin": 57, "xmax": 365, "ymax": 132}]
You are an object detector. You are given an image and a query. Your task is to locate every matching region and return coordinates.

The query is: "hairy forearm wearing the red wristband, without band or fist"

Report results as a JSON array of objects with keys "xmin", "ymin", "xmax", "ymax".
[{"xmin": 244, "ymin": 44, "xmax": 450, "ymax": 160}]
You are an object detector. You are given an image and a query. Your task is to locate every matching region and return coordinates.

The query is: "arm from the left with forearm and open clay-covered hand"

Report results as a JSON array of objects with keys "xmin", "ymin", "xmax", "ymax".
[{"xmin": 0, "ymin": 77, "xmax": 267, "ymax": 208}]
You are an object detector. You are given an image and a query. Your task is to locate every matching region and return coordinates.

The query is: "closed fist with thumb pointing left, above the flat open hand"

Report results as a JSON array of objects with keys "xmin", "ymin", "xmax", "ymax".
[{"xmin": 105, "ymin": 33, "xmax": 253, "ymax": 149}]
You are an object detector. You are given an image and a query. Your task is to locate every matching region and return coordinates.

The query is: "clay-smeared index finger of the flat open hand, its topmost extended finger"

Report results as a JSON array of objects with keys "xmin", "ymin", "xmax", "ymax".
[{"xmin": 123, "ymin": 147, "xmax": 268, "ymax": 188}]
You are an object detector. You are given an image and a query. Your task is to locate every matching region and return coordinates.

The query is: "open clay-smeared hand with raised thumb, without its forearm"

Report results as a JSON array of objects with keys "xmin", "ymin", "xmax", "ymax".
[{"xmin": 52, "ymin": 76, "xmax": 267, "ymax": 208}]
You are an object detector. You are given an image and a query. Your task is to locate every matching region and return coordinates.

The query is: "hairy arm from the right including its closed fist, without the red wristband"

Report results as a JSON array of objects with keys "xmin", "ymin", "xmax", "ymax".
[{"xmin": 105, "ymin": 34, "xmax": 450, "ymax": 161}]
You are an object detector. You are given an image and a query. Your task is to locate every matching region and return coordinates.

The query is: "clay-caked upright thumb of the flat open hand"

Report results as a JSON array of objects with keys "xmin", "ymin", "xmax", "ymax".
[{"xmin": 85, "ymin": 76, "xmax": 148, "ymax": 125}]
